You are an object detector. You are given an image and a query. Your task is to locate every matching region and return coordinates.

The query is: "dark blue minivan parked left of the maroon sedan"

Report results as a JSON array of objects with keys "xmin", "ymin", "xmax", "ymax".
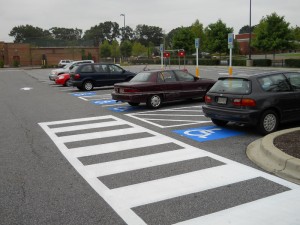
[{"xmin": 70, "ymin": 63, "xmax": 136, "ymax": 91}]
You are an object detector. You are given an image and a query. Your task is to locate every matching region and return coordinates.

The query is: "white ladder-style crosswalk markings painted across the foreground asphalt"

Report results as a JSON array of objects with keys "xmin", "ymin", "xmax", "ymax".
[{"xmin": 39, "ymin": 116, "xmax": 300, "ymax": 224}]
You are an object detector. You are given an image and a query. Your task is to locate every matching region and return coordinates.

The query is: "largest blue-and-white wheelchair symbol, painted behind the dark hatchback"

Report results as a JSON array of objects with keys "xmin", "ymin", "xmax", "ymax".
[{"xmin": 173, "ymin": 126, "xmax": 244, "ymax": 142}]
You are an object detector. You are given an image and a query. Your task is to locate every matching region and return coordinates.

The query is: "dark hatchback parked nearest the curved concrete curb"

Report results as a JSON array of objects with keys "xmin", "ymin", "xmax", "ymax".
[{"xmin": 203, "ymin": 72, "xmax": 300, "ymax": 134}]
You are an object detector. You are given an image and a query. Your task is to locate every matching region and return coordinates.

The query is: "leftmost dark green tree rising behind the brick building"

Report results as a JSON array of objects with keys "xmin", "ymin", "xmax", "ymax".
[{"xmin": 9, "ymin": 25, "xmax": 52, "ymax": 43}]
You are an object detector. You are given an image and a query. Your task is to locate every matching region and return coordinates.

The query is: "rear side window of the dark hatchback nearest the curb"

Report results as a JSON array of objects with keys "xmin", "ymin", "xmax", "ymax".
[{"xmin": 258, "ymin": 74, "xmax": 291, "ymax": 92}]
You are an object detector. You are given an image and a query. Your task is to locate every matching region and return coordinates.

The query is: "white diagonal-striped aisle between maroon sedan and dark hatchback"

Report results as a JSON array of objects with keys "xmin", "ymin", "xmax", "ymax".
[{"xmin": 126, "ymin": 105, "xmax": 211, "ymax": 128}]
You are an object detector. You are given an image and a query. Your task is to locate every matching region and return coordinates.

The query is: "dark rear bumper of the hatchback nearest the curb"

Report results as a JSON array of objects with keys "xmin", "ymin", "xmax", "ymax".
[{"xmin": 202, "ymin": 105, "xmax": 260, "ymax": 125}]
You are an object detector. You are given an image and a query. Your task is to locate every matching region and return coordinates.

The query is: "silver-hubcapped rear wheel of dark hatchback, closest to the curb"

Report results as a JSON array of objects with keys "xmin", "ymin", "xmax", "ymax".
[{"xmin": 258, "ymin": 110, "xmax": 279, "ymax": 135}]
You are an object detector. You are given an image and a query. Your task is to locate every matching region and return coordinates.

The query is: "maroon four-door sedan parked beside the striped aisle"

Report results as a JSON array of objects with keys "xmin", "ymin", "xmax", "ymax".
[{"xmin": 111, "ymin": 70, "xmax": 215, "ymax": 109}]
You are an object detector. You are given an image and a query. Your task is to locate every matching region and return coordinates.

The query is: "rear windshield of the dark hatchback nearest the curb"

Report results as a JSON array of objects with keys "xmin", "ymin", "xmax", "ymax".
[{"xmin": 210, "ymin": 78, "xmax": 251, "ymax": 94}]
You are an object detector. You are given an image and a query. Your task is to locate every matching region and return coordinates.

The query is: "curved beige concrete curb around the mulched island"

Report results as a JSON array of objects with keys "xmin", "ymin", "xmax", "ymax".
[{"xmin": 246, "ymin": 127, "xmax": 300, "ymax": 184}]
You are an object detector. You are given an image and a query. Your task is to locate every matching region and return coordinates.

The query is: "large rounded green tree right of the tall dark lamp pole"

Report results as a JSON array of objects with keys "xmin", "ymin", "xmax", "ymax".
[{"xmin": 252, "ymin": 13, "xmax": 293, "ymax": 58}]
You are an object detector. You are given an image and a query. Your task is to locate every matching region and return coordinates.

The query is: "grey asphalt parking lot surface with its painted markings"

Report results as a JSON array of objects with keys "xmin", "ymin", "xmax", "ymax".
[{"xmin": 0, "ymin": 66, "xmax": 300, "ymax": 225}]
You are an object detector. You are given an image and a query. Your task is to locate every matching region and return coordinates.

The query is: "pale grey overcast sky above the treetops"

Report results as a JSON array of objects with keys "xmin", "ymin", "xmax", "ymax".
[{"xmin": 0, "ymin": 0, "xmax": 300, "ymax": 42}]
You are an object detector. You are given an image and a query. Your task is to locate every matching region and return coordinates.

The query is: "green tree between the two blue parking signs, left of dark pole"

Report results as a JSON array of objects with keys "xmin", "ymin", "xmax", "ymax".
[{"xmin": 204, "ymin": 19, "xmax": 233, "ymax": 55}]
